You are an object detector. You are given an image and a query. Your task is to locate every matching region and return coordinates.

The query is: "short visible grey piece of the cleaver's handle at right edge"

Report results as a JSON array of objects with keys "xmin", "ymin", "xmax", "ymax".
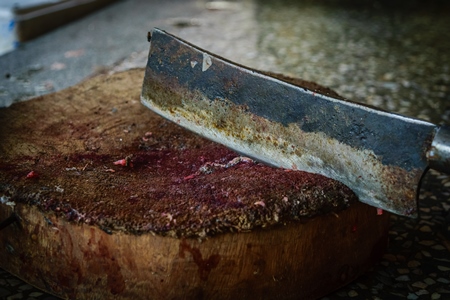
[{"xmin": 427, "ymin": 126, "xmax": 450, "ymax": 174}]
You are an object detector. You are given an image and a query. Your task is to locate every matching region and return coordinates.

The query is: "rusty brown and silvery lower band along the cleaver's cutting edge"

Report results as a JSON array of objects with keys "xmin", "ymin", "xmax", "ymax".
[{"xmin": 143, "ymin": 77, "xmax": 422, "ymax": 216}]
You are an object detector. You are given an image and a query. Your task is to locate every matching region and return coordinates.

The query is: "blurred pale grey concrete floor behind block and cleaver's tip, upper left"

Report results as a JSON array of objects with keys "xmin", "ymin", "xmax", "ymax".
[{"xmin": 0, "ymin": 0, "xmax": 268, "ymax": 107}]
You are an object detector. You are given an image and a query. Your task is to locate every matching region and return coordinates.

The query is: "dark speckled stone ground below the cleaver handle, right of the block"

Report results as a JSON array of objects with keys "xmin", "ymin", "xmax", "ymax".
[{"xmin": 323, "ymin": 171, "xmax": 450, "ymax": 300}]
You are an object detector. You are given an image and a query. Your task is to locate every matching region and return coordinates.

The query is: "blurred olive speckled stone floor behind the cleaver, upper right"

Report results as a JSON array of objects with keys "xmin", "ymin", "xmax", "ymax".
[{"xmin": 255, "ymin": 0, "xmax": 450, "ymax": 122}]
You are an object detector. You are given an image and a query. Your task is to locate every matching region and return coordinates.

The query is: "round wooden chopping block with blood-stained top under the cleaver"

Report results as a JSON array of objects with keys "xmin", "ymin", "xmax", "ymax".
[{"xmin": 0, "ymin": 69, "xmax": 389, "ymax": 299}]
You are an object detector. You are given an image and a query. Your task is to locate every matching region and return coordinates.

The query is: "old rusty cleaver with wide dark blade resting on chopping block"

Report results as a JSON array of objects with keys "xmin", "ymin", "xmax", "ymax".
[{"xmin": 141, "ymin": 28, "xmax": 450, "ymax": 217}]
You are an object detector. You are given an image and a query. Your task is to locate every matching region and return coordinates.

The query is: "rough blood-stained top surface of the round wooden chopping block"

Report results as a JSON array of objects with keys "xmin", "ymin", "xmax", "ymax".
[{"xmin": 0, "ymin": 70, "xmax": 357, "ymax": 237}]
